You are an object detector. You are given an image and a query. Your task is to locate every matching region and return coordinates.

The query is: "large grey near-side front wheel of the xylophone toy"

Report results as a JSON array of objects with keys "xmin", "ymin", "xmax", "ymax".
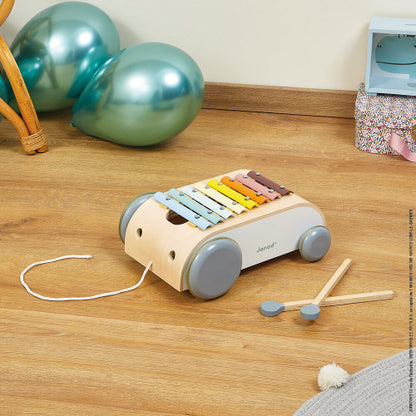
[{"xmin": 185, "ymin": 238, "xmax": 242, "ymax": 300}]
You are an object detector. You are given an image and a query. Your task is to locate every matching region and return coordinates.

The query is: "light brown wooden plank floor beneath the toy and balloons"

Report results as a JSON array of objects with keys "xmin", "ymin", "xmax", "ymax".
[{"xmin": 0, "ymin": 110, "xmax": 410, "ymax": 416}]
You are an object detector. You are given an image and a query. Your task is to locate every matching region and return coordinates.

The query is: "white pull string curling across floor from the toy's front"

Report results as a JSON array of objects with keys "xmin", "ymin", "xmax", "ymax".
[{"xmin": 20, "ymin": 254, "xmax": 152, "ymax": 302}]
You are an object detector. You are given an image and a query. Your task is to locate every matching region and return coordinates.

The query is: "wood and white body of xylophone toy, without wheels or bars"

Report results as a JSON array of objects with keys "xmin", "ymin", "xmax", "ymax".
[{"xmin": 125, "ymin": 170, "xmax": 325, "ymax": 291}]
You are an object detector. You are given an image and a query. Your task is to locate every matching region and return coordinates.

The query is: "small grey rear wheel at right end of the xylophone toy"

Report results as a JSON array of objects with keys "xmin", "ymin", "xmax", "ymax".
[{"xmin": 299, "ymin": 225, "xmax": 331, "ymax": 261}]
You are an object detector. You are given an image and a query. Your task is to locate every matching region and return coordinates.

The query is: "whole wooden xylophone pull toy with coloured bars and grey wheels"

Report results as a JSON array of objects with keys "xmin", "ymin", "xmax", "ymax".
[{"xmin": 119, "ymin": 170, "xmax": 331, "ymax": 300}]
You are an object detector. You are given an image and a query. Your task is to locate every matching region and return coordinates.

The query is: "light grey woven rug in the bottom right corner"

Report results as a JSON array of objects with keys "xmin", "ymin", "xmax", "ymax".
[{"xmin": 293, "ymin": 349, "xmax": 416, "ymax": 416}]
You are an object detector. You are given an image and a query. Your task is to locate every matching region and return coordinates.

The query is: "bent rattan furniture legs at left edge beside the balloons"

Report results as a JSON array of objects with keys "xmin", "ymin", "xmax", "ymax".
[{"xmin": 0, "ymin": 0, "xmax": 48, "ymax": 155}]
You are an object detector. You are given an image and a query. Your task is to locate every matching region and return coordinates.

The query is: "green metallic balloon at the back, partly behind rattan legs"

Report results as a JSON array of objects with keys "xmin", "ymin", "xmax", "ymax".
[{"xmin": 9, "ymin": 2, "xmax": 120, "ymax": 111}]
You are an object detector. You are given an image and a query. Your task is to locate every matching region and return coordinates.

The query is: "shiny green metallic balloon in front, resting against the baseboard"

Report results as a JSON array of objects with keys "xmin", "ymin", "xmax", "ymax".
[{"xmin": 72, "ymin": 43, "xmax": 204, "ymax": 146}]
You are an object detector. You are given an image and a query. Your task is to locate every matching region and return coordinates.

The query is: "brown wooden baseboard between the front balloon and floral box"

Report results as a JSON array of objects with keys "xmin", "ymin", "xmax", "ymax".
[{"xmin": 203, "ymin": 82, "xmax": 358, "ymax": 118}]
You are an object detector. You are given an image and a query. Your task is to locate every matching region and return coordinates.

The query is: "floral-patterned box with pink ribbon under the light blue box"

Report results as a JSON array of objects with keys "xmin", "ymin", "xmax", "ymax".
[{"xmin": 355, "ymin": 84, "xmax": 416, "ymax": 162}]
